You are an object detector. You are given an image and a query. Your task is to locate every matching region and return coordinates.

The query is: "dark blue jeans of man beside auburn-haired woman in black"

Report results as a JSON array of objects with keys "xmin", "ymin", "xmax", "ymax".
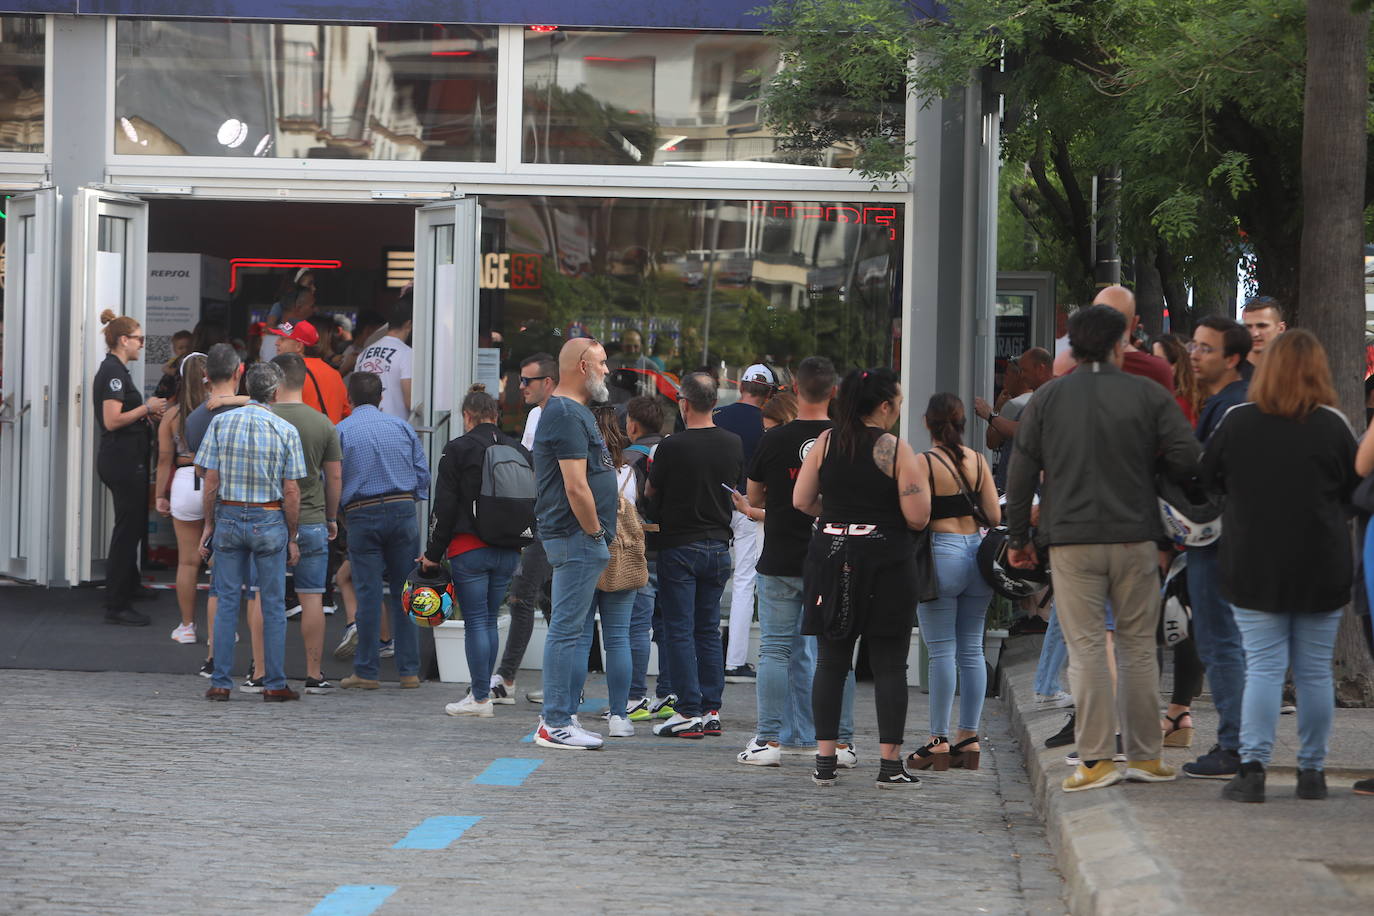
[{"xmin": 1189, "ymin": 545, "xmax": 1245, "ymax": 751}]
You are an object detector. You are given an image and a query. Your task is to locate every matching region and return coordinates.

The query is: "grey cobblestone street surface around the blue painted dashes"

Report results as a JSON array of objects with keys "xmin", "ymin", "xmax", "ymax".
[{"xmin": 0, "ymin": 670, "xmax": 1065, "ymax": 916}]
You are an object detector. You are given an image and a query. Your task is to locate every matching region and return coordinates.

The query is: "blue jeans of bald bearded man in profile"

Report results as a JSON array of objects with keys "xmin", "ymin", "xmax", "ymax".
[{"xmin": 544, "ymin": 531, "xmax": 610, "ymax": 728}]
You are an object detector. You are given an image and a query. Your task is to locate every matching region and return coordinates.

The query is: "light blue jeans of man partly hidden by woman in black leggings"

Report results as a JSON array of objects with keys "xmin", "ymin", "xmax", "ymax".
[{"xmin": 754, "ymin": 573, "xmax": 855, "ymax": 747}]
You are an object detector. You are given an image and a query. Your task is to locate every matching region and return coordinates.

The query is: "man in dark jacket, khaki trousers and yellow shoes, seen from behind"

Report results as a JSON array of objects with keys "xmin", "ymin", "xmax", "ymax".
[{"xmin": 1007, "ymin": 305, "xmax": 1201, "ymax": 792}]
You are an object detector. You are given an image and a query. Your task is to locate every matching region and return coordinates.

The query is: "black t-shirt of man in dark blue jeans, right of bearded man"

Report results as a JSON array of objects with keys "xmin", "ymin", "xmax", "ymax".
[{"xmin": 647, "ymin": 426, "xmax": 745, "ymax": 551}]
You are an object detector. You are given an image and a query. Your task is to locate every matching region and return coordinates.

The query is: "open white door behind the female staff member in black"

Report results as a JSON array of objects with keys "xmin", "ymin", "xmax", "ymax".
[{"xmin": 66, "ymin": 188, "xmax": 148, "ymax": 582}]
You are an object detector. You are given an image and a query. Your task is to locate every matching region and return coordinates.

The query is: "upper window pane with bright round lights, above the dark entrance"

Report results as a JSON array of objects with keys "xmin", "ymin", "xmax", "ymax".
[{"xmin": 114, "ymin": 19, "xmax": 496, "ymax": 162}]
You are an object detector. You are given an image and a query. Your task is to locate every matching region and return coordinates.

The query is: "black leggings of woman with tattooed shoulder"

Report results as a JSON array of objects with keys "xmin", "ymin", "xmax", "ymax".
[{"xmin": 811, "ymin": 629, "xmax": 911, "ymax": 744}]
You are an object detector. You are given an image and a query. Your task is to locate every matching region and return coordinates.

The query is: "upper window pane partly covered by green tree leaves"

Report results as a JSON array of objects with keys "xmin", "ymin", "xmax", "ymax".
[{"xmin": 521, "ymin": 29, "xmax": 873, "ymax": 168}]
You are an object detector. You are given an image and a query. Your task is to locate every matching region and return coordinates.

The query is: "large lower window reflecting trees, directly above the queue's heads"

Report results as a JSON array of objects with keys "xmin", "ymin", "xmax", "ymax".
[{"xmin": 478, "ymin": 196, "xmax": 903, "ymax": 422}]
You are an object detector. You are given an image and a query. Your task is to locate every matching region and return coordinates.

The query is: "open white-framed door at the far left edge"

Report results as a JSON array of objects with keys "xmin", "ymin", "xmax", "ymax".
[{"xmin": 0, "ymin": 188, "xmax": 58, "ymax": 585}]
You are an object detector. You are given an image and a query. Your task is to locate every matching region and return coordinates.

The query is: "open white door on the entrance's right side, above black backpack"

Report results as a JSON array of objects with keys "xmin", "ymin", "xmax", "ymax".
[{"xmin": 411, "ymin": 198, "xmax": 480, "ymax": 491}]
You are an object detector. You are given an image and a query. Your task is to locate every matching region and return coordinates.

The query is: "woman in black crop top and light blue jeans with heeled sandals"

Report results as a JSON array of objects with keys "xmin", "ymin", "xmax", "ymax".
[{"xmin": 907, "ymin": 391, "xmax": 1002, "ymax": 770}]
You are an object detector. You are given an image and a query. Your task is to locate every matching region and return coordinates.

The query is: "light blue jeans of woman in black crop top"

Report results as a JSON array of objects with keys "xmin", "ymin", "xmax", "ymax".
[{"xmin": 916, "ymin": 531, "xmax": 992, "ymax": 736}]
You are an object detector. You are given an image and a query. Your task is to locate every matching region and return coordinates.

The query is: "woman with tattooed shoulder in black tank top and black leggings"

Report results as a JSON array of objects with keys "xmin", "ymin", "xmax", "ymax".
[{"xmin": 793, "ymin": 369, "xmax": 930, "ymax": 788}]
